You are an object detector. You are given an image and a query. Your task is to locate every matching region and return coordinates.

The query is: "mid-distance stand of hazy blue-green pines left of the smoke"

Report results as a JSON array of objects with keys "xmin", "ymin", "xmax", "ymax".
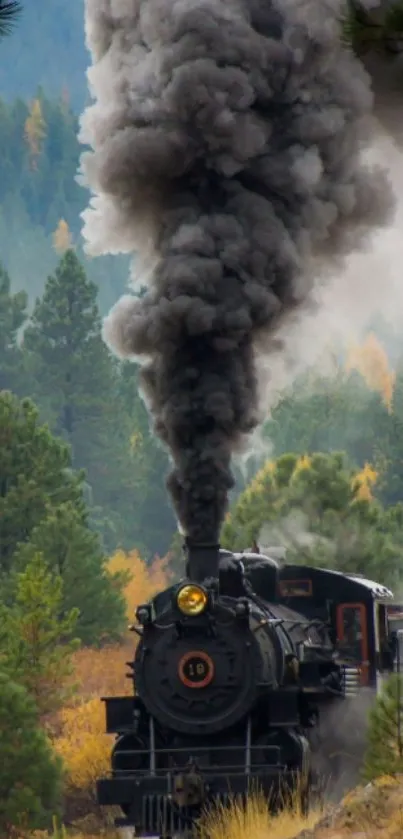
[{"xmin": 0, "ymin": 250, "xmax": 174, "ymax": 555}]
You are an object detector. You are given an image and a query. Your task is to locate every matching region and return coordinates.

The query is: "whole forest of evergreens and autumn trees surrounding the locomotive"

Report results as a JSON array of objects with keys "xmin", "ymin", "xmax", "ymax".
[{"xmin": 0, "ymin": 0, "xmax": 403, "ymax": 839}]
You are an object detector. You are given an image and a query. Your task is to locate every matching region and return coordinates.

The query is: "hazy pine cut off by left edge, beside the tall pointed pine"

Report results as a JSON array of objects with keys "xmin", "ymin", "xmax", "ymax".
[{"xmin": 0, "ymin": 263, "xmax": 27, "ymax": 393}]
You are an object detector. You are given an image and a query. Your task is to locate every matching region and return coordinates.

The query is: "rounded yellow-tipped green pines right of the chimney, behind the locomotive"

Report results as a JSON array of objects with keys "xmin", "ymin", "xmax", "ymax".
[{"xmin": 222, "ymin": 452, "xmax": 403, "ymax": 586}]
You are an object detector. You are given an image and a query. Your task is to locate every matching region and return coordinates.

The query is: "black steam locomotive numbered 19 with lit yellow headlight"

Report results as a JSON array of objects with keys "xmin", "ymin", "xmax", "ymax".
[{"xmin": 97, "ymin": 545, "xmax": 396, "ymax": 839}]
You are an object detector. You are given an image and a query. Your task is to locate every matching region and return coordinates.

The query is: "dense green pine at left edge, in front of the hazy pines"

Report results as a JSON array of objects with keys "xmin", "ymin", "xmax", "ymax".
[{"xmin": 0, "ymin": 392, "xmax": 125, "ymax": 642}]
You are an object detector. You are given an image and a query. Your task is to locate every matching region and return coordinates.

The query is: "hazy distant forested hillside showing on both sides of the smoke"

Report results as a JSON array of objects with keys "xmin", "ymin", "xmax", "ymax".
[{"xmin": 0, "ymin": 2, "xmax": 403, "ymax": 600}]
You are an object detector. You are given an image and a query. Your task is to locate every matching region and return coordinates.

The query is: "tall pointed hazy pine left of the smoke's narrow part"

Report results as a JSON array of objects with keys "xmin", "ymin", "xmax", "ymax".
[{"xmin": 24, "ymin": 250, "xmax": 137, "ymax": 548}]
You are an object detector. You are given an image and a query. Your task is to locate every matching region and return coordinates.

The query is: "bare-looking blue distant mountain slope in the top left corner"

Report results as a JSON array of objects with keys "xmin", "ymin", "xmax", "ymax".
[{"xmin": 0, "ymin": 0, "xmax": 89, "ymax": 113}]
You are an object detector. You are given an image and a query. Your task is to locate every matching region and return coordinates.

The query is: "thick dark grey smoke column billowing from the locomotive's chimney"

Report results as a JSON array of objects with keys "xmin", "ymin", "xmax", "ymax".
[{"xmin": 80, "ymin": 0, "xmax": 393, "ymax": 542}]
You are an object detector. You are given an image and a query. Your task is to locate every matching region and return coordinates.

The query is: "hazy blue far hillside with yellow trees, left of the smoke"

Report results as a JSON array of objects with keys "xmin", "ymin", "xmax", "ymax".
[{"xmin": 0, "ymin": 89, "xmax": 128, "ymax": 313}]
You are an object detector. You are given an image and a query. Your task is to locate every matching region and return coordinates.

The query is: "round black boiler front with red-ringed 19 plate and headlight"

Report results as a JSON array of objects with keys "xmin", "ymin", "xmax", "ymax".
[{"xmin": 134, "ymin": 558, "xmax": 285, "ymax": 735}]
